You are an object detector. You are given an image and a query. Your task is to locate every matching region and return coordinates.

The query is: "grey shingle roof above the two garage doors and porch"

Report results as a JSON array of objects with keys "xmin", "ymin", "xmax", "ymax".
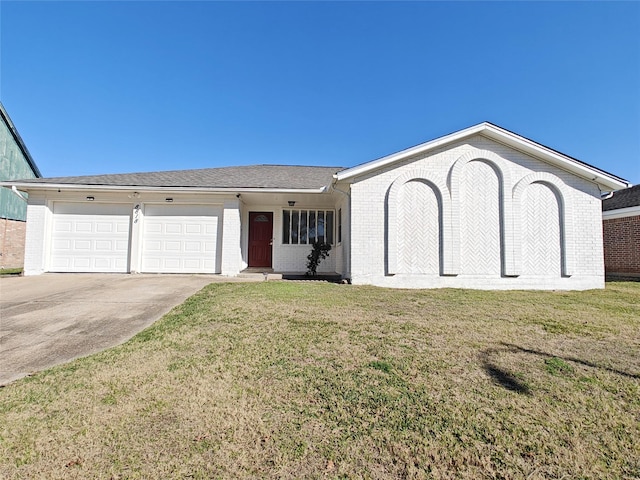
[{"xmin": 11, "ymin": 165, "xmax": 343, "ymax": 189}]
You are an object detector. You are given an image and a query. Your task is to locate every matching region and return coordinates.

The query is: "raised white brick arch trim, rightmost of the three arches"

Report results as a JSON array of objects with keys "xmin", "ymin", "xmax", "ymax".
[{"xmin": 512, "ymin": 172, "xmax": 574, "ymax": 277}]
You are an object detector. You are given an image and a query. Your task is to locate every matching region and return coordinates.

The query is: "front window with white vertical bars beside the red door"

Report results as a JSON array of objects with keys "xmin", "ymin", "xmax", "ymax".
[{"xmin": 282, "ymin": 209, "xmax": 333, "ymax": 245}]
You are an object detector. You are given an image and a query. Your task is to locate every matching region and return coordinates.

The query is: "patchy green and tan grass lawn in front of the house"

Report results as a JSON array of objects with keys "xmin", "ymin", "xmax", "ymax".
[{"xmin": 0, "ymin": 282, "xmax": 640, "ymax": 479}]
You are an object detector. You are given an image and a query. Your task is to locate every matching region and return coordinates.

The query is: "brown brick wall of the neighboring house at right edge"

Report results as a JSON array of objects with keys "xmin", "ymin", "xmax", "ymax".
[{"xmin": 603, "ymin": 215, "xmax": 640, "ymax": 275}]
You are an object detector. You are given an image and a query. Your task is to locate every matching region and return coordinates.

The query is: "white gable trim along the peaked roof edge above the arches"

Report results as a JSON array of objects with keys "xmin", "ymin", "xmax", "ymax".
[{"xmin": 336, "ymin": 122, "xmax": 629, "ymax": 191}]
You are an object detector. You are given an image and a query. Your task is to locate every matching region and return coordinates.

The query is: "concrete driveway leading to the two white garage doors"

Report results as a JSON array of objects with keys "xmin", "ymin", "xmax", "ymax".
[{"xmin": 0, "ymin": 274, "xmax": 240, "ymax": 385}]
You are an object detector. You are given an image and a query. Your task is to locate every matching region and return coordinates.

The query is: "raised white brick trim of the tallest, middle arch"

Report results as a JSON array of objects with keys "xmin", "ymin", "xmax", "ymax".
[{"xmin": 448, "ymin": 150, "xmax": 517, "ymax": 276}]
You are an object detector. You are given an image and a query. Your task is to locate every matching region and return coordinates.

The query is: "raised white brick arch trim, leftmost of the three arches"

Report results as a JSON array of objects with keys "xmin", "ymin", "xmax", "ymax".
[{"xmin": 386, "ymin": 169, "xmax": 451, "ymax": 275}]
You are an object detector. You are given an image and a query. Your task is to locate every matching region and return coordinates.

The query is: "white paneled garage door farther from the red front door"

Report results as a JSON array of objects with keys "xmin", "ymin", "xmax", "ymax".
[{"xmin": 50, "ymin": 202, "xmax": 131, "ymax": 273}]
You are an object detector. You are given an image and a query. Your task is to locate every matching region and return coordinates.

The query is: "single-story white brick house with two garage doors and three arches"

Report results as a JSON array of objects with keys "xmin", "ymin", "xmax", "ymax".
[{"xmin": 2, "ymin": 123, "xmax": 627, "ymax": 289}]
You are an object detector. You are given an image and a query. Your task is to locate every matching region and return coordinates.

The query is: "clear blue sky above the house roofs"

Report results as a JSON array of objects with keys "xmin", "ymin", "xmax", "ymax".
[{"xmin": 0, "ymin": 0, "xmax": 640, "ymax": 183}]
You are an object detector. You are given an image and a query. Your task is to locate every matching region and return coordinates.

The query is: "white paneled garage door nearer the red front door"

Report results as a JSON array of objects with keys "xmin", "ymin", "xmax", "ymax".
[{"xmin": 141, "ymin": 205, "xmax": 222, "ymax": 273}]
